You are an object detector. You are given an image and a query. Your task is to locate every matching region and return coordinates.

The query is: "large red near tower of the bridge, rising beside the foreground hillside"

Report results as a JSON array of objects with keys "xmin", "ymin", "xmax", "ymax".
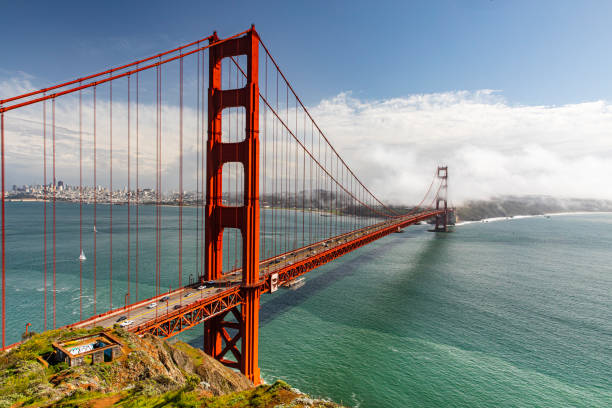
[{"xmin": 204, "ymin": 27, "xmax": 263, "ymax": 385}]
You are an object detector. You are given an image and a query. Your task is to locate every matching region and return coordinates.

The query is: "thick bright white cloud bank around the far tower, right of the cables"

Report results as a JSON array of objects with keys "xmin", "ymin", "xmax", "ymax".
[{"xmin": 312, "ymin": 90, "xmax": 612, "ymax": 203}]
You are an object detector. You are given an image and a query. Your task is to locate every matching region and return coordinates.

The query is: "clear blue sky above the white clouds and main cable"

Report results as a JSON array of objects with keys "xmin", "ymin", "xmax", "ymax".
[{"xmin": 0, "ymin": 0, "xmax": 612, "ymax": 105}]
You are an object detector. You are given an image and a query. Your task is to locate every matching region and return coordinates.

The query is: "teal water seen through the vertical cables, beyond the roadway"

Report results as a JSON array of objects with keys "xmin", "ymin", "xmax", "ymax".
[{"xmin": 0, "ymin": 202, "xmax": 366, "ymax": 338}]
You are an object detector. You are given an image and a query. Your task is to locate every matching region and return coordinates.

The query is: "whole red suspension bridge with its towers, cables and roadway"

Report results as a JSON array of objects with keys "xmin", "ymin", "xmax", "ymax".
[{"xmin": 0, "ymin": 27, "xmax": 452, "ymax": 383}]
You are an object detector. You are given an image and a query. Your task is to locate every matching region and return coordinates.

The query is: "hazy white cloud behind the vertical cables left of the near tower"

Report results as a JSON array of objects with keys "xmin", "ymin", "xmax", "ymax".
[{"xmin": 0, "ymin": 76, "xmax": 213, "ymax": 190}]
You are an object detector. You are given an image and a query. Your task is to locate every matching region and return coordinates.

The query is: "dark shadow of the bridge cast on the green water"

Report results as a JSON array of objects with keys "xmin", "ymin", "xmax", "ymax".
[{"xmin": 294, "ymin": 234, "xmax": 449, "ymax": 336}]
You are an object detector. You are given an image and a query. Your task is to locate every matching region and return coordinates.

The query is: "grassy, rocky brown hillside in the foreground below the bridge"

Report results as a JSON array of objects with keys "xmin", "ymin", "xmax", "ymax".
[{"xmin": 0, "ymin": 329, "xmax": 339, "ymax": 408}]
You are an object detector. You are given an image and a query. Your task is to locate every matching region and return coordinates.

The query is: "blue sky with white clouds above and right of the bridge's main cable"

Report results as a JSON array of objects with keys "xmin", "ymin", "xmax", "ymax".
[{"xmin": 0, "ymin": 0, "xmax": 612, "ymax": 203}]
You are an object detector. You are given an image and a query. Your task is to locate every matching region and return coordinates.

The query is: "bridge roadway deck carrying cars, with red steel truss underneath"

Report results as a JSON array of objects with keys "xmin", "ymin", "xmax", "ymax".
[{"xmin": 70, "ymin": 211, "xmax": 443, "ymax": 338}]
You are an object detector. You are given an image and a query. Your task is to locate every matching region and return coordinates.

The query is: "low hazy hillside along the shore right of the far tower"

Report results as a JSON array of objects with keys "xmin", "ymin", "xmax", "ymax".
[{"xmin": 457, "ymin": 196, "xmax": 612, "ymax": 221}]
